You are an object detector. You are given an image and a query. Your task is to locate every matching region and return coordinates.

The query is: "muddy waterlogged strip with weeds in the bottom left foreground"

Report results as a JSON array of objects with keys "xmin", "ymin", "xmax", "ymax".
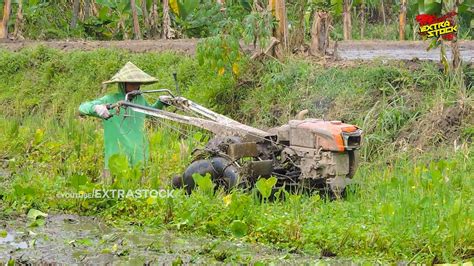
[{"xmin": 0, "ymin": 215, "xmax": 342, "ymax": 265}]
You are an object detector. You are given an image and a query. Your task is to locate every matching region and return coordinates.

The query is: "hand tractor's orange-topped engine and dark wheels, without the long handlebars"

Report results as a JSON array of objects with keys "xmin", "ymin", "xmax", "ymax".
[{"xmin": 175, "ymin": 119, "xmax": 362, "ymax": 195}]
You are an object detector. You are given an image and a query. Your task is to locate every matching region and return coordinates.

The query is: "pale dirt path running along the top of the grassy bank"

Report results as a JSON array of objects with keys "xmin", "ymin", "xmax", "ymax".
[{"xmin": 0, "ymin": 39, "xmax": 474, "ymax": 63}]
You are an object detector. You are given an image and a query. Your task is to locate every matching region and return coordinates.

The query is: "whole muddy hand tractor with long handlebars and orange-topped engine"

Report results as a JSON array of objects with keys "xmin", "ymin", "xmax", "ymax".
[{"xmin": 110, "ymin": 89, "xmax": 362, "ymax": 196}]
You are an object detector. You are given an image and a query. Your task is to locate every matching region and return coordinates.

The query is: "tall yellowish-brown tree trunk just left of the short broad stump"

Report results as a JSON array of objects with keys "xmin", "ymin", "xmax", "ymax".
[{"xmin": 268, "ymin": 0, "xmax": 288, "ymax": 58}]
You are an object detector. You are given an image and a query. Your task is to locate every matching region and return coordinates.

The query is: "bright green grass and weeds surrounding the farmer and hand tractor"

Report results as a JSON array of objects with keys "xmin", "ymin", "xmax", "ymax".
[{"xmin": 0, "ymin": 47, "xmax": 474, "ymax": 263}]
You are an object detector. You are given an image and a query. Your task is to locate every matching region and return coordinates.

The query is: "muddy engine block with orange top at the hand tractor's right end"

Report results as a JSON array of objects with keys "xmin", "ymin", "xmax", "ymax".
[{"xmin": 271, "ymin": 119, "xmax": 362, "ymax": 192}]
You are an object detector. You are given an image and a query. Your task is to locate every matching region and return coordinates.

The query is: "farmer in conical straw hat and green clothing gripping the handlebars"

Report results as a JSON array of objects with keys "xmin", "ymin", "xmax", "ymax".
[{"xmin": 79, "ymin": 62, "xmax": 164, "ymax": 178}]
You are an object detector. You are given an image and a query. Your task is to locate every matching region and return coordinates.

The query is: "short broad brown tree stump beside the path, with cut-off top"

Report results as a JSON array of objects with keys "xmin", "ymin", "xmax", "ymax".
[{"xmin": 310, "ymin": 11, "xmax": 331, "ymax": 55}]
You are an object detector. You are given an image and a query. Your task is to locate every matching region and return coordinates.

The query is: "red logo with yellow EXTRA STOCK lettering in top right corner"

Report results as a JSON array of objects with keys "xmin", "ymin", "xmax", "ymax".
[{"xmin": 416, "ymin": 11, "xmax": 458, "ymax": 41}]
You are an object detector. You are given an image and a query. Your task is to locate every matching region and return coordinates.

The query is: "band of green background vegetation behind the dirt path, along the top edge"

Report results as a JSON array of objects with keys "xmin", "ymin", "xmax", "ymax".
[{"xmin": 0, "ymin": 0, "xmax": 474, "ymax": 40}]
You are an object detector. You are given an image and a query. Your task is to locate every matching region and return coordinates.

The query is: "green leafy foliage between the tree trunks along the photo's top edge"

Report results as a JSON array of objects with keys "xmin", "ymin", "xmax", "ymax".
[{"xmin": 0, "ymin": 0, "xmax": 474, "ymax": 40}]
